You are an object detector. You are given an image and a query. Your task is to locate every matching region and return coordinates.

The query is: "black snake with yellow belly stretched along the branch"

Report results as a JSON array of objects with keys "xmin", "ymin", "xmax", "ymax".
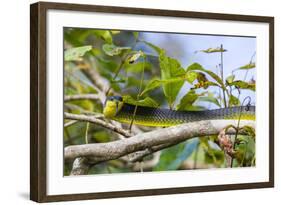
[{"xmin": 103, "ymin": 96, "xmax": 255, "ymax": 127}]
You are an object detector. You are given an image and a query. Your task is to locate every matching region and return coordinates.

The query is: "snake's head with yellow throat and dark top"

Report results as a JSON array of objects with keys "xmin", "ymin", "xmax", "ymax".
[{"xmin": 103, "ymin": 96, "xmax": 123, "ymax": 118}]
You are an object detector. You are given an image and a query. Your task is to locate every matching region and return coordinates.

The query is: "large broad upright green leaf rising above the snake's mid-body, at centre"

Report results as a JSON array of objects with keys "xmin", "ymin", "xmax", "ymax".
[{"xmin": 159, "ymin": 50, "xmax": 186, "ymax": 107}]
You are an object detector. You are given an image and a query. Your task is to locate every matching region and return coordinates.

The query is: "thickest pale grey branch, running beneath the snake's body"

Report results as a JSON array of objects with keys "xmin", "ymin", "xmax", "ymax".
[{"xmin": 64, "ymin": 118, "xmax": 255, "ymax": 164}]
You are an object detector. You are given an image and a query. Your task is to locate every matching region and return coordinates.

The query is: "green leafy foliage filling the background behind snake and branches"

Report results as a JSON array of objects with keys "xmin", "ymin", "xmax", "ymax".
[{"xmin": 64, "ymin": 28, "xmax": 255, "ymax": 175}]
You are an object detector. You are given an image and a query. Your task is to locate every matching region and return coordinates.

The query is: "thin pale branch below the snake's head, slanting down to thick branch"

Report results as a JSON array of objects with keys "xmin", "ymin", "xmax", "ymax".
[{"xmin": 64, "ymin": 112, "xmax": 132, "ymax": 137}]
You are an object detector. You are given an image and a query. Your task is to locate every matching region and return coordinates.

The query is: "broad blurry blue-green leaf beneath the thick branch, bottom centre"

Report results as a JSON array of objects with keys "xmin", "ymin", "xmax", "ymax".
[{"xmin": 153, "ymin": 138, "xmax": 199, "ymax": 171}]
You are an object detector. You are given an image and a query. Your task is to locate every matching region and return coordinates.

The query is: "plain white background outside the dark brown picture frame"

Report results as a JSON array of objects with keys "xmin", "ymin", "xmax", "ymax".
[{"xmin": 0, "ymin": 0, "xmax": 281, "ymax": 205}]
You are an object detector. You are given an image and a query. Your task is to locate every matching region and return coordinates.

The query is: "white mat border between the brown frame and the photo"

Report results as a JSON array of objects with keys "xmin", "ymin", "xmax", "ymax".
[{"xmin": 47, "ymin": 10, "xmax": 269, "ymax": 195}]
